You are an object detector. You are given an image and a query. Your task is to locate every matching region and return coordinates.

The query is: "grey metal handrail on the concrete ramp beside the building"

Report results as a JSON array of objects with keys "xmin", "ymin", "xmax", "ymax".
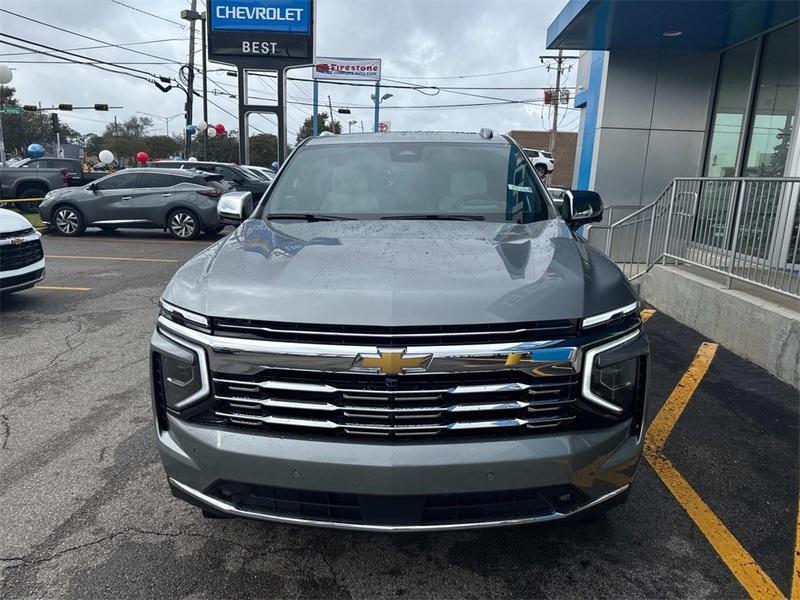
[{"xmin": 595, "ymin": 177, "xmax": 800, "ymax": 298}]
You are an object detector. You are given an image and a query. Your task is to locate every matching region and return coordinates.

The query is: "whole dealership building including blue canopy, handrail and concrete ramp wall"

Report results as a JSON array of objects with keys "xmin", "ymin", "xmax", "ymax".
[{"xmin": 547, "ymin": 0, "xmax": 800, "ymax": 387}]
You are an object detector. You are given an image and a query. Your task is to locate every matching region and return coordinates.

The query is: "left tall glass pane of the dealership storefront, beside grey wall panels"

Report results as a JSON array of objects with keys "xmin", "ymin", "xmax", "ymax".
[{"xmin": 705, "ymin": 40, "xmax": 757, "ymax": 177}]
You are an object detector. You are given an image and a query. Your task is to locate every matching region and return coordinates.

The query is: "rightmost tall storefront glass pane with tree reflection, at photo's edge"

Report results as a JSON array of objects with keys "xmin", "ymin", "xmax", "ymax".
[{"xmin": 742, "ymin": 22, "xmax": 800, "ymax": 177}]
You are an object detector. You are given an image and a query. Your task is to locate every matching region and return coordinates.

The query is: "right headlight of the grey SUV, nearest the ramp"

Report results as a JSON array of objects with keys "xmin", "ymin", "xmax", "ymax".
[{"xmin": 581, "ymin": 330, "xmax": 648, "ymax": 415}]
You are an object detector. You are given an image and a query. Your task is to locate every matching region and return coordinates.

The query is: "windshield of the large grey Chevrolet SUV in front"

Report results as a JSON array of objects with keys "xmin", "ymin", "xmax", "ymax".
[{"xmin": 265, "ymin": 142, "xmax": 553, "ymax": 223}]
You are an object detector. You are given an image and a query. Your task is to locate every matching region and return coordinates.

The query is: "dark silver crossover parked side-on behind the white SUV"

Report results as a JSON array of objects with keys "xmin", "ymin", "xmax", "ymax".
[{"xmin": 39, "ymin": 168, "xmax": 230, "ymax": 240}]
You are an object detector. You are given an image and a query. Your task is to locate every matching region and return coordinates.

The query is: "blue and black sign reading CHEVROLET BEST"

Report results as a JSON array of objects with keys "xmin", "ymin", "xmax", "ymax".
[{"xmin": 206, "ymin": 0, "xmax": 314, "ymax": 70}]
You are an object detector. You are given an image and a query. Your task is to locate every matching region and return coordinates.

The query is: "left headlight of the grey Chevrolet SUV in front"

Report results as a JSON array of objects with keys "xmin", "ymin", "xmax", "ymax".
[{"xmin": 153, "ymin": 330, "xmax": 210, "ymax": 410}]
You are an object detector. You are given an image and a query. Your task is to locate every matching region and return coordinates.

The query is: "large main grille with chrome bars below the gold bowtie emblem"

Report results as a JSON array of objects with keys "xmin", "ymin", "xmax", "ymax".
[{"xmin": 198, "ymin": 370, "xmax": 578, "ymax": 438}]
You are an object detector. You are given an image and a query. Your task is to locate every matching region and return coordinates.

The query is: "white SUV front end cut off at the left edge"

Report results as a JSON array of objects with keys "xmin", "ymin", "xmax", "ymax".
[{"xmin": 0, "ymin": 208, "xmax": 44, "ymax": 294}]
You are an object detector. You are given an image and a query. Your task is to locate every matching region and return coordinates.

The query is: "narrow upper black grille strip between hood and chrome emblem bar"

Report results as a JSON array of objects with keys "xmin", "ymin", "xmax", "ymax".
[{"xmin": 211, "ymin": 317, "xmax": 578, "ymax": 346}]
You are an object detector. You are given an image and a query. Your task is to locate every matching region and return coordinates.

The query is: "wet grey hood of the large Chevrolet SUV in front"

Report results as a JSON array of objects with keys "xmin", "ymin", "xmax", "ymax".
[{"xmin": 164, "ymin": 219, "xmax": 636, "ymax": 326}]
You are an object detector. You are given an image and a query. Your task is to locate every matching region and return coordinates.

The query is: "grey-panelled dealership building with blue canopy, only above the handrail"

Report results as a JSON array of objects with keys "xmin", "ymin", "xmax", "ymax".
[{"xmin": 547, "ymin": 0, "xmax": 800, "ymax": 205}]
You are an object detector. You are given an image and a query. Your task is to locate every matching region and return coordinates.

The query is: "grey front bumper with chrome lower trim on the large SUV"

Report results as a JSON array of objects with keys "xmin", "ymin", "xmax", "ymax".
[{"xmin": 158, "ymin": 416, "xmax": 642, "ymax": 532}]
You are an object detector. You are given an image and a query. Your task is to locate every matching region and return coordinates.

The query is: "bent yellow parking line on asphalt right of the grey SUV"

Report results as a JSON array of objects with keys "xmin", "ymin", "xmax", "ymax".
[{"xmin": 644, "ymin": 342, "xmax": 784, "ymax": 599}]
